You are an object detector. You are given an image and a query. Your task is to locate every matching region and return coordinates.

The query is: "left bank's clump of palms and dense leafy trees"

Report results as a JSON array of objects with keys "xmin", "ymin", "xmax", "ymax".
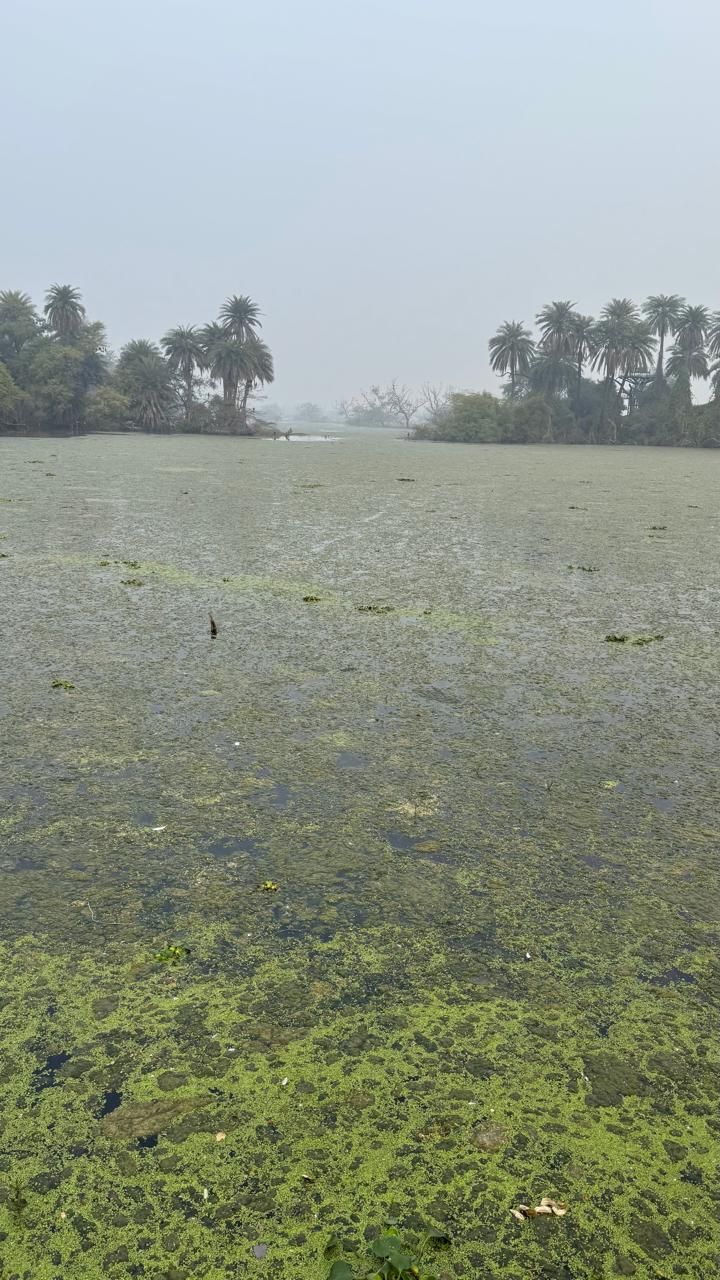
[{"xmin": 0, "ymin": 284, "xmax": 274, "ymax": 434}]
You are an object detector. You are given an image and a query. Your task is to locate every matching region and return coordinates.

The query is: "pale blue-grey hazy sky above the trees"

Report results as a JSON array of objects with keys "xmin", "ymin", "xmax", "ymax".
[{"xmin": 0, "ymin": 0, "xmax": 720, "ymax": 403}]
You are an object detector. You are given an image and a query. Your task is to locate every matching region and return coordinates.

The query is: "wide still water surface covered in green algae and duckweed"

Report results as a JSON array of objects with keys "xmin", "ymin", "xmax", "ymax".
[{"xmin": 0, "ymin": 433, "xmax": 720, "ymax": 1280}]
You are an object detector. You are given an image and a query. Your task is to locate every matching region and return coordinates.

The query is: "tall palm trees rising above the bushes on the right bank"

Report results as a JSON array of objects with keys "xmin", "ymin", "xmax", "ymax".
[{"xmin": 488, "ymin": 293, "xmax": 720, "ymax": 411}]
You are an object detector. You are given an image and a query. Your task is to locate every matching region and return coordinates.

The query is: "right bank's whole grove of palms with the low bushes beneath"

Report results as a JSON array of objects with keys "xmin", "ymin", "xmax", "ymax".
[{"xmin": 415, "ymin": 293, "xmax": 720, "ymax": 448}]
